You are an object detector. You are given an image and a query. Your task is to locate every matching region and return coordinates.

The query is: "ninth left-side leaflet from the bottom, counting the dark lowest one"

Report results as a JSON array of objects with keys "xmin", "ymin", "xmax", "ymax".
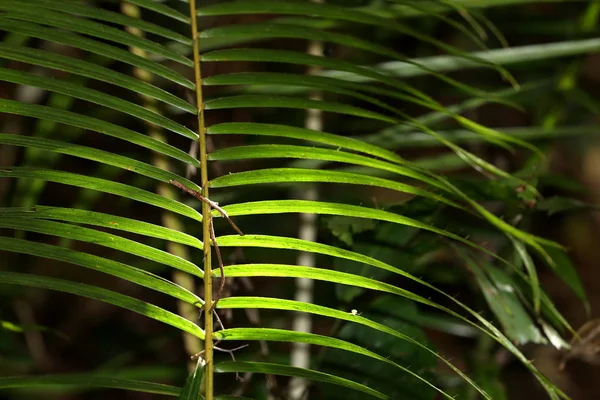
[{"xmin": 0, "ymin": 68, "xmax": 197, "ymax": 139}]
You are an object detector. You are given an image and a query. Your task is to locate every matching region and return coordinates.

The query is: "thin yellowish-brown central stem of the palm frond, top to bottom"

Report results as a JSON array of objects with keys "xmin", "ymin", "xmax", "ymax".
[{"xmin": 190, "ymin": 0, "xmax": 214, "ymax": 400}]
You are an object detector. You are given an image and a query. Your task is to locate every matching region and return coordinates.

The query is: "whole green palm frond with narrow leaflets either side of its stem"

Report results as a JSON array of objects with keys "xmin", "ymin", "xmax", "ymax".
[{"xmin": 0, "ymin": 0, "xmax": 598, "ymax": 400}]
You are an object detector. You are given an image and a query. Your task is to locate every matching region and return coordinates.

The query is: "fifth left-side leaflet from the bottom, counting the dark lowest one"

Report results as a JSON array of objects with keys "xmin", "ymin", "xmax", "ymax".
[{"xmin": 0, "ymin": 206, "xmax": 203, "ymax": 249}]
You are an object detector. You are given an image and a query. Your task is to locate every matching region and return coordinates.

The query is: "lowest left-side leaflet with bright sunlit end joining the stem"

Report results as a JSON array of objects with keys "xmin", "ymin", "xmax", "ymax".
[{"xmin": 0, "ymin": 271, "xmax": 204, "ymax": 339}]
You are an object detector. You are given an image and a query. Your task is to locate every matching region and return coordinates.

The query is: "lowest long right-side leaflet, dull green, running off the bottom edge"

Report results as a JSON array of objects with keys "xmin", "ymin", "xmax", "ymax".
[{"xmin": 215, "ymin": 361, "xmax": 388, "ymax": 399}]
